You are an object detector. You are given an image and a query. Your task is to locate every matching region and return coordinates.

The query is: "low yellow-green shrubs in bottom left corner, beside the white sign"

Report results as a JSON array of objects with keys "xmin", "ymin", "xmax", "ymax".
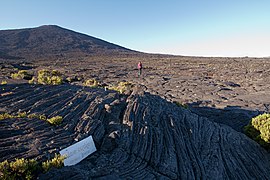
[{"xmin": 0, "ymin": 154, "xmax": 65, "ymax": 180}]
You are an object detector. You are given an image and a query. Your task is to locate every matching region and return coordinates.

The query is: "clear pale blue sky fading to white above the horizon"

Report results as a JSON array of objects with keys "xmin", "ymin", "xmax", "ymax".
[{"xmin": 0, "ymin": 0, "xmax": 270, "ymax": 56}]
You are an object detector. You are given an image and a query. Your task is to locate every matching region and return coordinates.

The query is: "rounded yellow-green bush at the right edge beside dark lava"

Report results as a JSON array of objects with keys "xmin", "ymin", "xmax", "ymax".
[{"xmin": 244, "ymin": 113, "xmax": 270, "ymax": 151}]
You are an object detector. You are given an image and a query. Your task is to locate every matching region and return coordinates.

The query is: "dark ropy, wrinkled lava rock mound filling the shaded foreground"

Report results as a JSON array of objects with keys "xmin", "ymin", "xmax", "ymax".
[{"xmin": 0, "ymin": 84, "xmax": 270, "ymax": 179}]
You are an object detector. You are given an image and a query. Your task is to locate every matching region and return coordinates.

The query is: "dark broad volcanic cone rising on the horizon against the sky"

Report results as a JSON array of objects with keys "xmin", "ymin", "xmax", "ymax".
[{"xmin": 0, "ymin": 25, "xmax": 138, "ymax": 59}]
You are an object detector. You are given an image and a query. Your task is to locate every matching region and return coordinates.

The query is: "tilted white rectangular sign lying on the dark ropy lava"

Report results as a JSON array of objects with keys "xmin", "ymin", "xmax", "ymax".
[{"xmin": 60, "ymin": 136, "xmax": 97, "ymax": 166}]
